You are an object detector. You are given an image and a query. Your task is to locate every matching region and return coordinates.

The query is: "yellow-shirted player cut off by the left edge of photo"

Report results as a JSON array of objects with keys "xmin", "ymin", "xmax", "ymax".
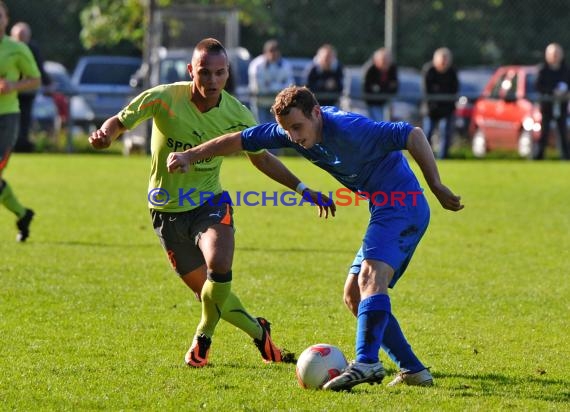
[{"xmin": 0, "ymin": 0, "xmax": 40, "ymax": 242}]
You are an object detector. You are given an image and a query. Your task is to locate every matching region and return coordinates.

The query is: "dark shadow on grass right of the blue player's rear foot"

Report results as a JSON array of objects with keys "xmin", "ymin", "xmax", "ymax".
[{"xmin": 433, "ymin": 372, "xmax": 570, "ymax": 402}]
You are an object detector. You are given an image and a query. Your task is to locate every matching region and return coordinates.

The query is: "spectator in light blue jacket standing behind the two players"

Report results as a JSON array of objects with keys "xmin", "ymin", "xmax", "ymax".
[{"xmin": 248, "ymin": 39, "xmax": 295, "ymax": 123}]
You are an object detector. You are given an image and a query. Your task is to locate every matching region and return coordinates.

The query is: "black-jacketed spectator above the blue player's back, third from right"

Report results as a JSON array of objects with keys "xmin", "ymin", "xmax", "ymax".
[{"xmin": 363, "ymin": 47, "xmax": 398, "ymax": 122}]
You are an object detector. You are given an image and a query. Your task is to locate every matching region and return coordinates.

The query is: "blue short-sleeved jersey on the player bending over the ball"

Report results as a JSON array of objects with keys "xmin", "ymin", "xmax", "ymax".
[{"xmin": 242, "ymin": 106, "xmax": 421, "ymax": 193}]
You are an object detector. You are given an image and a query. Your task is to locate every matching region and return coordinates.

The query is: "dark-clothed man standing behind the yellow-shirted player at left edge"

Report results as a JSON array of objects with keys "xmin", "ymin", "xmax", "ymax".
[{"xmin": 10, "ymin": 22, "xmax": 51, "ymax": 152}]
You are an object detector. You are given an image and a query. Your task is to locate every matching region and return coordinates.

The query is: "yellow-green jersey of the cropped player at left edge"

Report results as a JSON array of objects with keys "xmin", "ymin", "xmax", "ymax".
[{"xmin": 0, "ymin": 35, "xmax": 40, "ymax": 114}]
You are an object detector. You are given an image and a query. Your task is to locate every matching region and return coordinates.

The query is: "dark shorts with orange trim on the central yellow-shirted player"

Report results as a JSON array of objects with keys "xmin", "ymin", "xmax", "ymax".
[{"xmin": 150, "ymin": 193, "xmax": 234, "ymax": 276}]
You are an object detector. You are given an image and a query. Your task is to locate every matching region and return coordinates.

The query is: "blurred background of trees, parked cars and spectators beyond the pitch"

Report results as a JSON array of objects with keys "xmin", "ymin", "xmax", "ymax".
[{"xmin": 6, "ymin": 0, "xmax": 570, "ymax": 159}]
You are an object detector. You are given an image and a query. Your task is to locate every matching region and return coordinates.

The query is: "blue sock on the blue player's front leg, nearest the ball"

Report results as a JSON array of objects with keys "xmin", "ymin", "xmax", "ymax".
[{"xmin": 356, "ymin": 295, "xmax": 391, "ymax": 363}]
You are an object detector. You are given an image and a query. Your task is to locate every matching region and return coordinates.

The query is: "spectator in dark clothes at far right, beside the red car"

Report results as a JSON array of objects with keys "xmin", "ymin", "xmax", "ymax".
[{"xmin": 533, "ymin": 43, "xmax": 570, "ymax": 160}]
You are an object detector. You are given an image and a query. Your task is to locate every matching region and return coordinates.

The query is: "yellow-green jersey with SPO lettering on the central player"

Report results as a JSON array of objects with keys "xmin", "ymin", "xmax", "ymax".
[{"xmin": 118, "ymin": 82, "xmax": 256, "ymax": 212}]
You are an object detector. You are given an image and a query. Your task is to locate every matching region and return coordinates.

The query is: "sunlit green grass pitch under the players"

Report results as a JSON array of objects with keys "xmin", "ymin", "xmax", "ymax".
[{"xmin": 0, "ymin": 154, "xmax": 570, "ymax": 411}]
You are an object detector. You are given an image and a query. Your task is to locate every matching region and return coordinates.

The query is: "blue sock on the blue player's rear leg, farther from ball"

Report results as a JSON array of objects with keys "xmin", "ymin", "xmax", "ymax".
[{"xmin": 382, "ymin": 314, "xmax": 426, "ymax": 373}]
